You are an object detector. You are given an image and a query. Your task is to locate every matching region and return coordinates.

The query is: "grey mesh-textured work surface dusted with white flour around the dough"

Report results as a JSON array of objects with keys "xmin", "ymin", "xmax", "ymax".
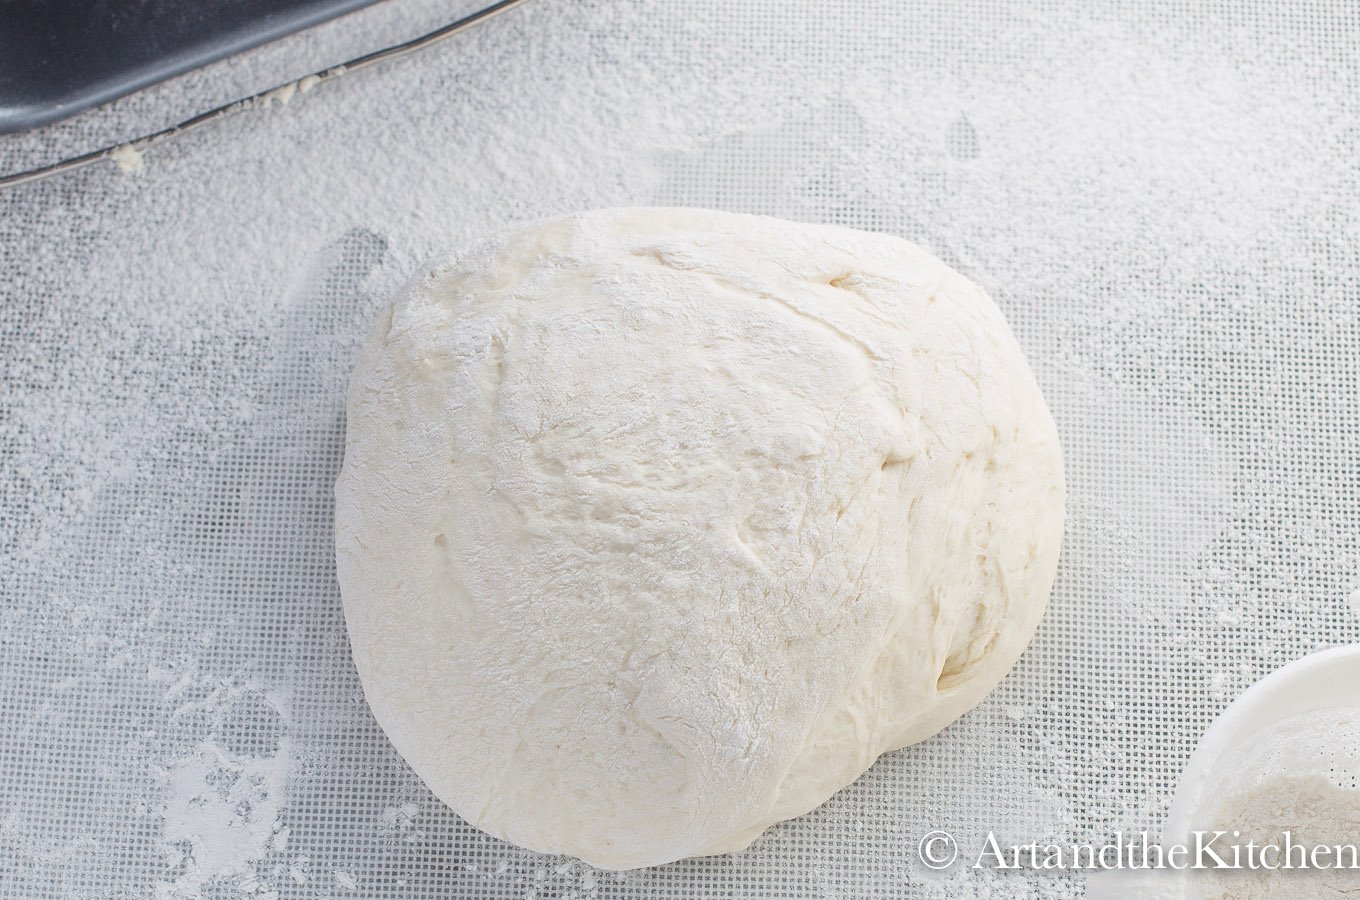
[{"xmin": 0, "ymin": 0, "xmax": 1360, "ymax": 900}]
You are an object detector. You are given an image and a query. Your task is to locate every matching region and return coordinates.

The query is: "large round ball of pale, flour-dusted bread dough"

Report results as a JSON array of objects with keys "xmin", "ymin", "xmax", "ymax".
[{"xmin": 336, "ymin": 209, "xmax": 1064, "ymax": 869}]
